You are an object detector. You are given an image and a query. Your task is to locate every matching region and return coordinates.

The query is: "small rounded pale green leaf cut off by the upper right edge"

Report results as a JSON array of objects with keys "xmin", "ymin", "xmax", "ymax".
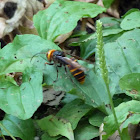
[{"xmin": 120, "ymin": 11, "xmax": 140, "ymax": 30}]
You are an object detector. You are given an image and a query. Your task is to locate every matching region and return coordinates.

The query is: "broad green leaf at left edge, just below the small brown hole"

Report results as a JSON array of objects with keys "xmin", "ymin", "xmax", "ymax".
[{"xmin": 0, "ymin": 68, "xmax": 43, "ymax": 119}]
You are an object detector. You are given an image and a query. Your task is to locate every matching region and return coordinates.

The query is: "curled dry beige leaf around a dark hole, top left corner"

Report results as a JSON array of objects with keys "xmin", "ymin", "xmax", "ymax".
[{"xmin": 0, "ymin": 0, "xmax": 44, "ymax": 38}]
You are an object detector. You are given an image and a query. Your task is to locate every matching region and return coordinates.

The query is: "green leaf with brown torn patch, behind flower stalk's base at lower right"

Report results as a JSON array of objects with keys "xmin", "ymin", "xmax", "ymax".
[{"xmin": 103, "ymin": 100, "xmax": 140, "ymax": 140}]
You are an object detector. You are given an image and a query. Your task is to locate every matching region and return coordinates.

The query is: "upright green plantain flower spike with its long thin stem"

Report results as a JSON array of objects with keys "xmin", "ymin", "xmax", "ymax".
[{"xmin": 96, "ymin": 21, "xmax": 123, "ymax": 140}]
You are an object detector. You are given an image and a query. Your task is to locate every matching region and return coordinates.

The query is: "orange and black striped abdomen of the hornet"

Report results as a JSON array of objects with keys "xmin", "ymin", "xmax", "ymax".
[{"xmin": 68, "ymin": 65, "xmax": 85, "ymax": 84}]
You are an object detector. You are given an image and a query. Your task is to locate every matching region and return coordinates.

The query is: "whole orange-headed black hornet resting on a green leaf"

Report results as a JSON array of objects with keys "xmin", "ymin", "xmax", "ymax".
[{"xmin": 46, "ymin": 50, "xmax": 85, "ymax": 84}]
